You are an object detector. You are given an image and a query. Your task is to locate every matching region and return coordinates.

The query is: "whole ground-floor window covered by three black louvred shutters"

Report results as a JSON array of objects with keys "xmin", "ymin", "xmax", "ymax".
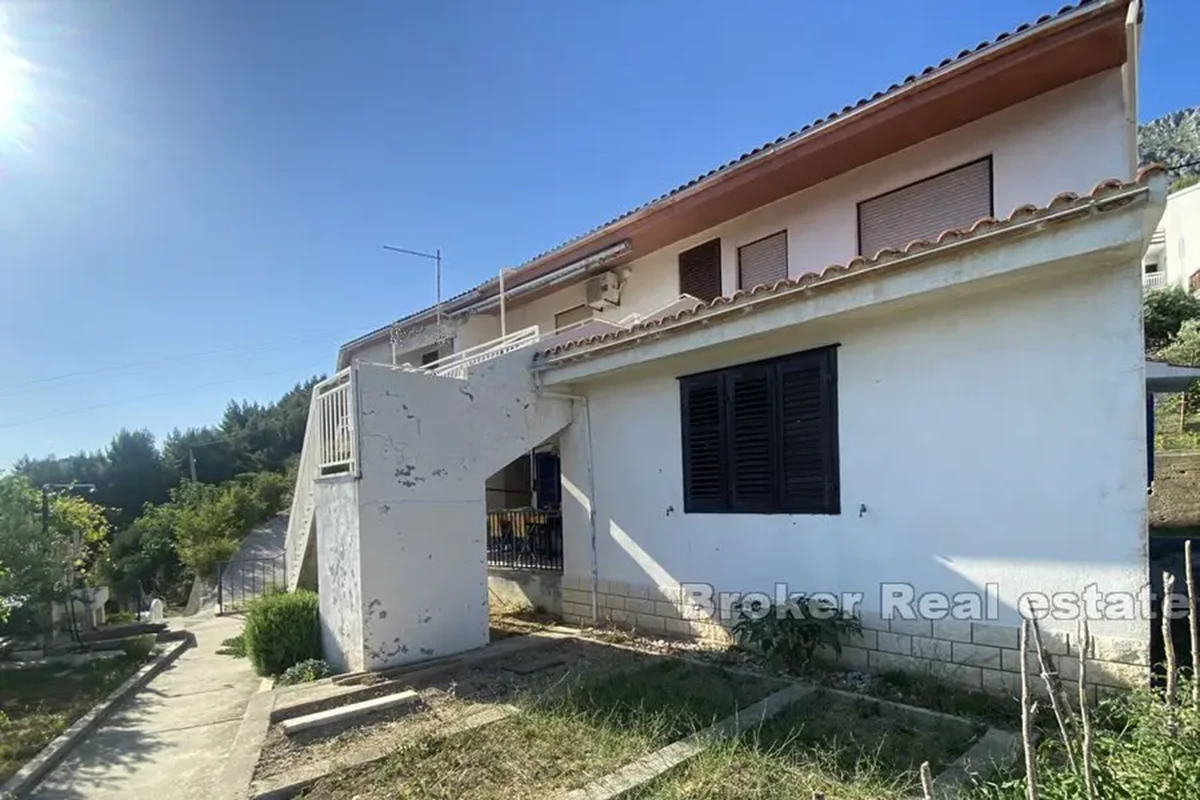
[{"xmin": 679, "ymin": 347, "xmax": 841, "ymax": 515}]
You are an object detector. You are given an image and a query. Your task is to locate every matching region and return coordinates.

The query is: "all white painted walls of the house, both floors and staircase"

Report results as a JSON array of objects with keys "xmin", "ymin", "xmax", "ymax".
[{"xmin": 297, "ymin": 54, "xmax": 1161, "ymax": 669}]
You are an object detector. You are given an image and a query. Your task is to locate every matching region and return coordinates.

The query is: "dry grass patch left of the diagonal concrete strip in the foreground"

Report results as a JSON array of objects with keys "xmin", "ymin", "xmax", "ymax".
[{"xmin": 295, "ymin": 661, "xmax": 776, "ymax": 800}]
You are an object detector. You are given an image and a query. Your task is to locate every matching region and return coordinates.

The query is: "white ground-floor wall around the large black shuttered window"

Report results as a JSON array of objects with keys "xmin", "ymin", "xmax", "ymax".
[{"xmin": 560, "ymin": 259, "xmax": 1147, "ymax": 638}]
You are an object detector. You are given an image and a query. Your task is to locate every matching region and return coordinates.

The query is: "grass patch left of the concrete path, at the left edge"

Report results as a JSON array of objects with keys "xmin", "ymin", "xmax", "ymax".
[{"xmin": 0, "ymin": 657, "xmax": 142, "ymax": 780}]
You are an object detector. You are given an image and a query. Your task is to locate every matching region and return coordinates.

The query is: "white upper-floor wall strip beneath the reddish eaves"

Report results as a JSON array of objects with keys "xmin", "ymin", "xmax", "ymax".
[{"xmin": 345, "ymin": 70, "xmax": 1123, "ymax": 361}]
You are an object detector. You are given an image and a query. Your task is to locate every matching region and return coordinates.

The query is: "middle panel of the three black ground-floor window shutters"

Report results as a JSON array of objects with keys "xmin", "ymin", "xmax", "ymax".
[{"xmin": 724, "ymin": 365, "xmax": 776, "ymax": 512}]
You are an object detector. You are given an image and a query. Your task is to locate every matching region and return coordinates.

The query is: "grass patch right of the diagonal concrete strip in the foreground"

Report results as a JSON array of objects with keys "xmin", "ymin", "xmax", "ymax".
[{"xmin": 630, "ymin": 693, "xmax": 978, "ymax": 800}]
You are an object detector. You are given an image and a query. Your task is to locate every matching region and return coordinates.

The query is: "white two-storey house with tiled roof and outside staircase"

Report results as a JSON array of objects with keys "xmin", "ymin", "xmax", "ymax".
[{"xmin": 288, "ymin": 0, "xmax": 1168, "ymax": 688}]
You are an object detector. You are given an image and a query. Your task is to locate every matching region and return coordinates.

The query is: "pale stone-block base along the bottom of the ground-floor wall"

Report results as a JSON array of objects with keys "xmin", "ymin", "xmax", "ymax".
[{"xmin": 563, "ymin": 575, "xmax": 1150, "ymax": 694}]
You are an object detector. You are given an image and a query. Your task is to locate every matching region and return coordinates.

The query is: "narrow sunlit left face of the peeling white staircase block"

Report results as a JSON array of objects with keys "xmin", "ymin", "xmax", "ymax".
[{"xmin": 314, "ymin": 476, "xmax": 362, "ymax": 672}]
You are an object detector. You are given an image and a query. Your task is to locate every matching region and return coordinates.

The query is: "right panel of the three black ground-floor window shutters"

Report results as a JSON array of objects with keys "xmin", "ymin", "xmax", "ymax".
[{"xmin": 778, "ymin": 348, "xmax": 841, "ymax": 513}]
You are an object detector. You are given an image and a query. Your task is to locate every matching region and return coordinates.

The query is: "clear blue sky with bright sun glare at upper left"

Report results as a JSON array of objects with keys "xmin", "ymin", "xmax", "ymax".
[{"xmin": 0, "ymin": 0, "xmax": 1200, "ymax": 467}]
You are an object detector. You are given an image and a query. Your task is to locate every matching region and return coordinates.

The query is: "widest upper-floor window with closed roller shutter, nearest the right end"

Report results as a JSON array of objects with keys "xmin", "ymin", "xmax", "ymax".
[{"xmin": 858, "ymin": 156, "xmax": 992, "ymax": 258}]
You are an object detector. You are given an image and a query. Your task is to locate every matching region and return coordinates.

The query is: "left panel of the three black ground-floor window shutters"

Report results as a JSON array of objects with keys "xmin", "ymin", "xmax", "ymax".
[{"xmin": 679, "ymin": 373, "xmax": 726, "ymax": 512}]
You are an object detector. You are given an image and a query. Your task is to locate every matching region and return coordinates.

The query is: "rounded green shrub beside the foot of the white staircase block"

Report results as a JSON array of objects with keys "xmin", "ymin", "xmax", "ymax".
[{"xmin": 242, "ymin": 590, "xmax": 322, "ymax": 675}]
